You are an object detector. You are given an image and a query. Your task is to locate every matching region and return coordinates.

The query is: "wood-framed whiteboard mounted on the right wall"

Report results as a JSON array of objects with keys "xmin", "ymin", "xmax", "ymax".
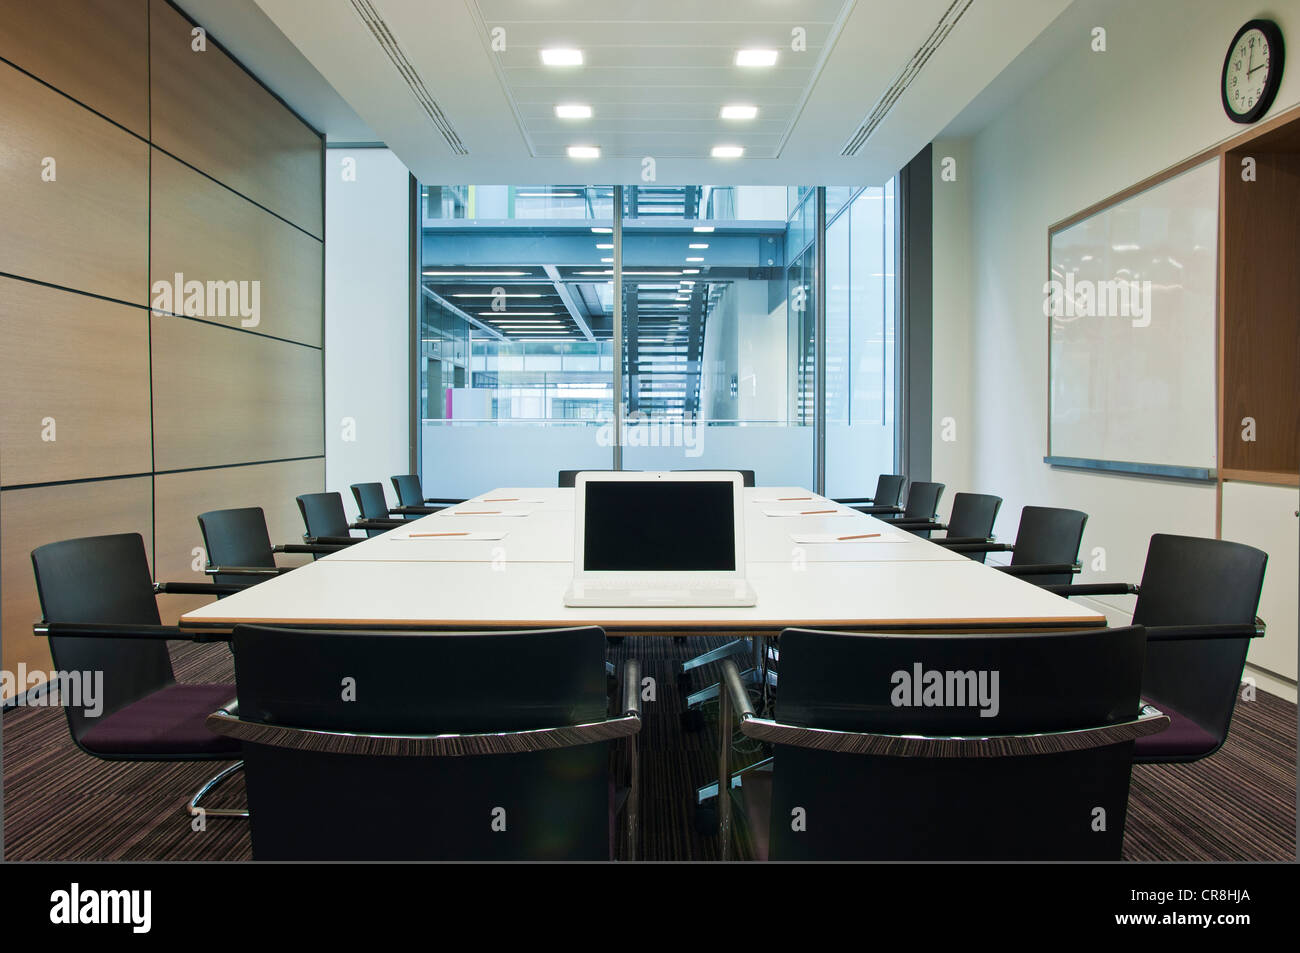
[{"xmin": 1043, "ymin": 157, "xmax": 1219, "ymax": 477}]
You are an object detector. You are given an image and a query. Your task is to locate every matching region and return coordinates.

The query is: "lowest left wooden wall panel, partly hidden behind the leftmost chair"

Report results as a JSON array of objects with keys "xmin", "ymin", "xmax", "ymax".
[{"xmin": 0, "ymin": 477, "xmax": 152, "ymax": 696}]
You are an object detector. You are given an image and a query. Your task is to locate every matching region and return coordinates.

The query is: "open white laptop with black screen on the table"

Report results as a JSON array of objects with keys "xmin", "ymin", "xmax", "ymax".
[{"xmin": 564, "ymin": 471, "xmax": 758, "ymax": 607}]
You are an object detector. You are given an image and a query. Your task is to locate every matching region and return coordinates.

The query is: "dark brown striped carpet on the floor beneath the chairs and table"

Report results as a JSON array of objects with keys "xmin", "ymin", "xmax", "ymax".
[{"xmin": 3, "ymin": 637, "xmax": 1296, "ymax": 861}]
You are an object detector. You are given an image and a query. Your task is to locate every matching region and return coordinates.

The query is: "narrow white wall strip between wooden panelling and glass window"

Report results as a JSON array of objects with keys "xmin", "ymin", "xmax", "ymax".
[{"xmin": 325, "ymin": 150, "xmax": 411, "ymax": 519}]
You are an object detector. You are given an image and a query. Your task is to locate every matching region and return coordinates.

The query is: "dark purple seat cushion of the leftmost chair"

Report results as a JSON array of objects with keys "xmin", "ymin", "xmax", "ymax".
[{"xmin": 82, "ymin": 684, "xmax": 241, "ymax": 761}]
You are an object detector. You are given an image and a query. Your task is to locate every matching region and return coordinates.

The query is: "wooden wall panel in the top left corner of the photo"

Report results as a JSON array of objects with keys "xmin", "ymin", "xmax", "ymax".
[{"xmin": 0, "ymin": 0, "xmax": 150, "ymax": 138}]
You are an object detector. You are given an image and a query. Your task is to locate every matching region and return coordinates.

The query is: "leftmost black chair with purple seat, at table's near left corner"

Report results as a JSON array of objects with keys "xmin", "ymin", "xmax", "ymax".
[{"xmin": 31, "ymin": 533, "xmax": 248, "ymax": 816}]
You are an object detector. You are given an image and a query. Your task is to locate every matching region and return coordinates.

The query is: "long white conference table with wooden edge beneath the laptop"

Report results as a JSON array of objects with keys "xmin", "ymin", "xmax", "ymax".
[{"xmin": 179, "ymin": 486, "xmax": 1106, "ymax": 636}]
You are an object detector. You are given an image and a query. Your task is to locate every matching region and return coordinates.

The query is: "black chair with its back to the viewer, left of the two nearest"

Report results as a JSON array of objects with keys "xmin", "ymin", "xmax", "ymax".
[{"xmin": 208, "ymin": 625, "xmax": 641, "ymax": 861}]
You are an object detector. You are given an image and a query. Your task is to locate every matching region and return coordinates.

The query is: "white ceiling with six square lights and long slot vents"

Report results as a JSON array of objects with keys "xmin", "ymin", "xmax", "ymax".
[{"xmin": 245, "ymin": 0, "xmax": 1070, "ymax": 185}]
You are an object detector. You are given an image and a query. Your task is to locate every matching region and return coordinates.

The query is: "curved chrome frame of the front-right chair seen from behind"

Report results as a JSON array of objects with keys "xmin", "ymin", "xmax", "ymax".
[{"xmin": 718, "ymin": 659, "xmax": 1169, "ymax": 861}]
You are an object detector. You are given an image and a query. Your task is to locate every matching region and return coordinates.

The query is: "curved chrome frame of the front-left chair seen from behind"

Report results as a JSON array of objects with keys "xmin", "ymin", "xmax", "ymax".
[{"xmin": 200, "ymin": 659, "xmax": 641, "ymax": 861}]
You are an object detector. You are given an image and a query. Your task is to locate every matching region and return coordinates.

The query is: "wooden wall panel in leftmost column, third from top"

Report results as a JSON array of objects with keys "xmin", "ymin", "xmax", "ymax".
[{"xmin": 0, "ymin": 278, "xmax": 153, "ymax": 486}]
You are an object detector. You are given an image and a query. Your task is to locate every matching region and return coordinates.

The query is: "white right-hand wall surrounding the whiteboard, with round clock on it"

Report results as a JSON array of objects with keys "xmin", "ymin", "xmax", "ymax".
[{"xmin": 935, "ymin": 0, "xmax": 1300, "ymax": 691}]
